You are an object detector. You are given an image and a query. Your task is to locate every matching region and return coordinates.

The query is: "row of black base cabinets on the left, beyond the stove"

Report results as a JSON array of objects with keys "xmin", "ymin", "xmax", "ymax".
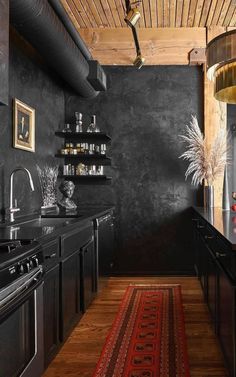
[{"xmin": 44, "ymin": 223, "xmax": 97, "ymax": 368}]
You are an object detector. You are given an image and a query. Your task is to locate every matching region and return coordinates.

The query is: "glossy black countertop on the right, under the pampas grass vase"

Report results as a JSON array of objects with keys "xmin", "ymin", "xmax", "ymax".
[{"xmin": 193, "ymin": 207, "xmax": 236, "ymax": 250}]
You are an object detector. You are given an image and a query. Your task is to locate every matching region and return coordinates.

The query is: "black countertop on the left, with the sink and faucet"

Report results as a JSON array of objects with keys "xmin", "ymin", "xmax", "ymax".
[{"xmin": 0, "ymin": 207, "xmax": 114, "ymax": 242}]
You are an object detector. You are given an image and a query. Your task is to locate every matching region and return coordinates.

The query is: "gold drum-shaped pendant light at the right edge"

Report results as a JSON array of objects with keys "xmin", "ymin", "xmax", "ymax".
[{"xmin": 206, "ymin": 30, "xmax": 236, "ymax": 104}]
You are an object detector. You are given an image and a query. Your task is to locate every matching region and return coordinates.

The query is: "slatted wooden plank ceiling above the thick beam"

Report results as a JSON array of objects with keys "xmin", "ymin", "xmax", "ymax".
[{"xmin": 61, "ymin": 0, "xmax": 236, "ymax": 28}]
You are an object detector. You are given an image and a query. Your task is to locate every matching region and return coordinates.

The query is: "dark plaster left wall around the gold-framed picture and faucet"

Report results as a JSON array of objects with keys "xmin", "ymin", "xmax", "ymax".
[{"xmin": 0, "ymin": 31, "xmax": 65, "ymax": 220}]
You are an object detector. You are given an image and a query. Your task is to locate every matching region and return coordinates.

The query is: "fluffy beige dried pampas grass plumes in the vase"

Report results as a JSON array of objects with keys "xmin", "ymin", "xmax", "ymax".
[{"xmin": 179, "ymin": 116, "xmax": 228, "ymax": 186}]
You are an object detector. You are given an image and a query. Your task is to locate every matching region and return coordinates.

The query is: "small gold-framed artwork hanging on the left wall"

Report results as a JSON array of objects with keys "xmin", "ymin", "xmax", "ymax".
[{"xmin": 13, "ymin": 98, "xmax": 35, "ymax": 152}]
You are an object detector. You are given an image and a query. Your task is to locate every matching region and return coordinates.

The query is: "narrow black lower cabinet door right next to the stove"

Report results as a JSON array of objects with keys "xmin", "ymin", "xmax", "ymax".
[{"xmin": 44, "ymin": 265, "xmax": 59, "ymax": 367}]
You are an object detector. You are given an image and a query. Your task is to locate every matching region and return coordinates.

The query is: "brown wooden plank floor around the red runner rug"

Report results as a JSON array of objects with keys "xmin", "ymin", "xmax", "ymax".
[{"xmin": 43, "ymin": 277, "xmax": 228, "ymax": 377}]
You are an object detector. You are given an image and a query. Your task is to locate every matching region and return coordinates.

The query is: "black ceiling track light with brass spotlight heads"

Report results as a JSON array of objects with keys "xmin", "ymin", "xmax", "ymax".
[{"xmin": 124, "ymin": 0, "xmax": 145, "ymax": 69}]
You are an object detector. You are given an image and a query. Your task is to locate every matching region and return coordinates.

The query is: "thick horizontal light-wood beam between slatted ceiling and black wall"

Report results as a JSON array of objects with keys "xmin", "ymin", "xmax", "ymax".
[{"xmin": 80, "ymin": 28, "xmax": 206, "ymax": 65}]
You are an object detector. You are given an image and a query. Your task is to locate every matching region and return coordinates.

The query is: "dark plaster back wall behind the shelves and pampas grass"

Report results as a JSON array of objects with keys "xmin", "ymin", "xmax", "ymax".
[{"xmin": 66, "ymin": 66, "xmax": 203, "ymax": 274}]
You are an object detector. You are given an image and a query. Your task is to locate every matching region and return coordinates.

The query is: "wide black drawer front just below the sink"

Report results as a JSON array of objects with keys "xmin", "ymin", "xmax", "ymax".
[{"xmin": 61, "ymin": 222, "xmax": 93, "ymax": 257}]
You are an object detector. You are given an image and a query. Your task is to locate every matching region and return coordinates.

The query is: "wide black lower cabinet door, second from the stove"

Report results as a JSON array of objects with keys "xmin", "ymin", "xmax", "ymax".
[{"xmin": 61, "ymin": 252, "xmax": 82, "ymax": 341}]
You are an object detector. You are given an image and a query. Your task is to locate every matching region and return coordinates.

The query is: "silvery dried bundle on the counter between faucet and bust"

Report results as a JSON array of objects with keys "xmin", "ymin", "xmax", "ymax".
[{"xmin": 37, "ymin": 165, "xmax": 58, "ymax": 207}]
